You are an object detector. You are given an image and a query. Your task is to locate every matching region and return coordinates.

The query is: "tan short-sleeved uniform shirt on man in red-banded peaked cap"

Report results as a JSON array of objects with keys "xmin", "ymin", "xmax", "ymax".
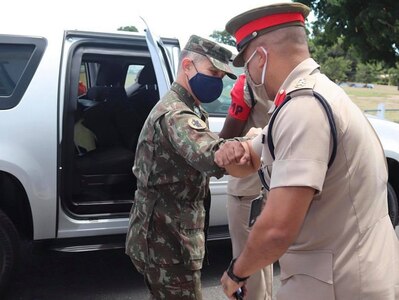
[{"xmin": 254, "ymin": 59, "xmax": 399, "ymax": 300}]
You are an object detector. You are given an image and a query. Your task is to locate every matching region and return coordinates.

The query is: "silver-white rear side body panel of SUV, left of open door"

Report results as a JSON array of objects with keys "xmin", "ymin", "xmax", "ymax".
[{"xmin": 0, "ymin": 35, "xmax": 62, "ymax": 239}]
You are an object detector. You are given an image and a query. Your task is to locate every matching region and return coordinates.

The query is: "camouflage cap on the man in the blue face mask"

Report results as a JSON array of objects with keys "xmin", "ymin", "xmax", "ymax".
[{"xmin": 184, "ymin": 35, "xmax": 237, "ymax": 79}]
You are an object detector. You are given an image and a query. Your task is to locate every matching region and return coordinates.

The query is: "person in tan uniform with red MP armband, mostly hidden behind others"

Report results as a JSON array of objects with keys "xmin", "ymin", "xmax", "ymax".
[{"xmin": 219, "ymin": 74, "xmax": 273, "ymax": 300}]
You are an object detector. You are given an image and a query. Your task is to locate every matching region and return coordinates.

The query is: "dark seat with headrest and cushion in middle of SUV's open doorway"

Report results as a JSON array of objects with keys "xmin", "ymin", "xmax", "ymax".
[{"xmin": 75, "ymin": 63, "xmax": 135, "ymax": 200}]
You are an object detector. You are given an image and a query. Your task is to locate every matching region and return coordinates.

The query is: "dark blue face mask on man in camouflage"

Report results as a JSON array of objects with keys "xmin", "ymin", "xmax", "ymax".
[{"xmin": 188, "ymin": 63, "xmax": 223, "ymax": 103}]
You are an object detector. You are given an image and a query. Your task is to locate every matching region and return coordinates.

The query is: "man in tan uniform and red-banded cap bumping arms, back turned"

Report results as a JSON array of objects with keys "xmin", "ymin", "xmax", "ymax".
[{"xmin": 215, "ymin": 3, "xmax": 399, "ymax": 300}]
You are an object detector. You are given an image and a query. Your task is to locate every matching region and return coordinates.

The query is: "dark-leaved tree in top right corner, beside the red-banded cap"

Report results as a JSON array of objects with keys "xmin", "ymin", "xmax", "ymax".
[{"xmin": 296, "ymin": 0, "xmax": 399, "ymax": 67}]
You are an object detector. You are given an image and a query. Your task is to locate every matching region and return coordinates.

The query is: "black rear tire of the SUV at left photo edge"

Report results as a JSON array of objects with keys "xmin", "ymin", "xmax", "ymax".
[{"xmin": 0, "ymin": 210, "xmax": 20, "ymax": 295}]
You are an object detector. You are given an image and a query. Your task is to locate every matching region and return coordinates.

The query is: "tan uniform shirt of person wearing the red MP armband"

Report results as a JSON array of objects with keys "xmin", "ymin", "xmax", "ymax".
[{"xmin": 227, "ymin": 85, "xmax": 273, "ymax": 196}]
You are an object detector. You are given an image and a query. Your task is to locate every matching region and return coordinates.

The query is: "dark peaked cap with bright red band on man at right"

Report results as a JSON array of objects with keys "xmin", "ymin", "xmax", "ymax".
[{"xmin": 226, "ymin": 2, "xmax": 310, "ymax": 67}]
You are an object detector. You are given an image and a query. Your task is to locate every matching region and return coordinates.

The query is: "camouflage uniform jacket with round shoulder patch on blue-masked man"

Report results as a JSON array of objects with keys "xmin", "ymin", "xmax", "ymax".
[{"xmin": 126, "ymin": 83, "xmax": 224, "ymax": 271}]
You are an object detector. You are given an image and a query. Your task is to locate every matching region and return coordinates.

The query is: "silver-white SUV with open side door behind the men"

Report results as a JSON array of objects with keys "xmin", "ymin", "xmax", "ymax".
[{"xmin": 0, "ymin": 24, "xmax": 399, "ymax": 290}]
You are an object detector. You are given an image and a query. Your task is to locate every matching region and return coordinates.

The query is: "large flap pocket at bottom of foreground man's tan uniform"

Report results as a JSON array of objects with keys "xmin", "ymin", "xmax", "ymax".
[{"xmin": 277, "ymin": 251, "xmax": 335, "ymax": 300}]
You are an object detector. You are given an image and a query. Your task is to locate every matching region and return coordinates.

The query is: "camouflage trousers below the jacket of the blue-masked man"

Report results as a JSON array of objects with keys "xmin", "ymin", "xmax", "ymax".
[{"xmin": 133, "ymin": 260, "xmax": 202, "ymax": 300}]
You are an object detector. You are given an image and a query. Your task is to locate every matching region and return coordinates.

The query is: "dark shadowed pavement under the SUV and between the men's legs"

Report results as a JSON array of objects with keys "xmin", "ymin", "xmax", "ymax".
[{"xmin": 2, "ymin": 226, "xmax": 399, "ymax": 300}]
